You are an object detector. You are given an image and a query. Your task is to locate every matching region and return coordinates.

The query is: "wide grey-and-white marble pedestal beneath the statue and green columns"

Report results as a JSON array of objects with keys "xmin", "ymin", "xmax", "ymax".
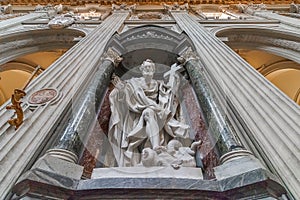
[{"xmin": 13, "ymin": 156, "xmax": 286, "ymax": 199}]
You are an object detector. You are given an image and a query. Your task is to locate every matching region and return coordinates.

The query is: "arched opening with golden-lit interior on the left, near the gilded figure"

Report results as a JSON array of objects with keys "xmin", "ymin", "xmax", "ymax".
[{"xmin": 0, "ymin": 29, "xmax": 85, "ymax": 105}]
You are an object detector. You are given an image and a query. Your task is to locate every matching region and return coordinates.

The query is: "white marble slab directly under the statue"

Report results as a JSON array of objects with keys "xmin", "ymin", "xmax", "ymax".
[{"xmin": 91, "ymin": 167, "xmax": 203, "ymax": 179}]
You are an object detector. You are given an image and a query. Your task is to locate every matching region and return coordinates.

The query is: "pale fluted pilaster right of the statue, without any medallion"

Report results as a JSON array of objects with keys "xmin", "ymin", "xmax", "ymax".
[{"xmin": 172, "ymin": 12, "xmax": 300, "ymax": 199}]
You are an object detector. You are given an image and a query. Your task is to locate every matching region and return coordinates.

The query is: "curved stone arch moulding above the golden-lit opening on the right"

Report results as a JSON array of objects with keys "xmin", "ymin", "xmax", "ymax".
[{"xmin": 212, "ymin": 26, "xmax": 300, "ymax": 63}]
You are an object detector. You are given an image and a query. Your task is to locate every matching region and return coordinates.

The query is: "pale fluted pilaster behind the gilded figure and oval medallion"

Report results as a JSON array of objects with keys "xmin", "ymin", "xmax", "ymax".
[{"xmin": 0, "ymin": 11, "xmax": 129, "ymax": 199}]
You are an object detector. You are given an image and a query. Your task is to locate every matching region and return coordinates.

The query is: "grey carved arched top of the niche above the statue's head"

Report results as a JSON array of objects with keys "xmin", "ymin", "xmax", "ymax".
[{"xmin": 107, "ymin": 25, "xmax": 194, "ymax": 76}]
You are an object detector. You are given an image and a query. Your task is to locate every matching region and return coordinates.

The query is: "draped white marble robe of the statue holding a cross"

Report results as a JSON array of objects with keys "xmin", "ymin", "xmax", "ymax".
[{"xmin": 108, "ymin": 77, "xmax": 189, "ymax": 167}]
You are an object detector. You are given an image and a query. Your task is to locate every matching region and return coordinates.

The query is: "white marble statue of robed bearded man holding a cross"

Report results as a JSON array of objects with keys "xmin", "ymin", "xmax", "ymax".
[{"xmin": 108, "ymin": 59, "xmax": 189, "ymax": 167}]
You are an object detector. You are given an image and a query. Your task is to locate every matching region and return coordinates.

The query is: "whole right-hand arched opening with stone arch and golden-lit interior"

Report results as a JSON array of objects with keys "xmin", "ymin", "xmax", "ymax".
[{"xmin": 213, "ymin": 26, "xmax": 300, "ymax": 104}]
